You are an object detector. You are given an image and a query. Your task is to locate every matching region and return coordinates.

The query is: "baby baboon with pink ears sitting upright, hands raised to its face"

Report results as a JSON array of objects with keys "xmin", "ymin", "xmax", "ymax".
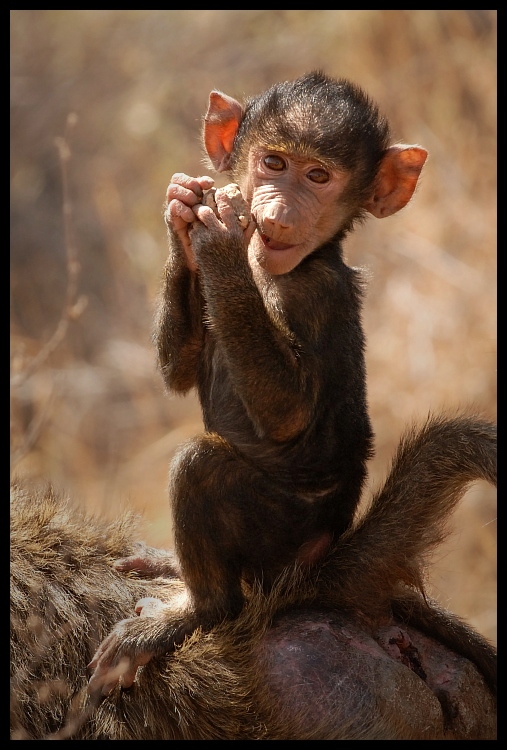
[{"xmin": 90, "ymin": 72, "xmax": 427, "ymax": 693}]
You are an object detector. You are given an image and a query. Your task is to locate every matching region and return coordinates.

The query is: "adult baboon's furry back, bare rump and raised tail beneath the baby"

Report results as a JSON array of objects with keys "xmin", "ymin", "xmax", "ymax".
[{"xmin": 11, "ymin": 416, "xmax": 496, "ymax": 740}]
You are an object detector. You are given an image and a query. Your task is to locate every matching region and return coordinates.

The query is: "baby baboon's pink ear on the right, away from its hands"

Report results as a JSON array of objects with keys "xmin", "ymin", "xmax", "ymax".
[{"xmin": 364, "ymin": 143, "xmax": 428, "ymax": 219}]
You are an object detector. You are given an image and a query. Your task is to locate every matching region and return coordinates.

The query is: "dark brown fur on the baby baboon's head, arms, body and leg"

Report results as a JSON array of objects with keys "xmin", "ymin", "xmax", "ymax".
[{"xmin": 156, "ymin": 74, "xmax": 412, "ymax": 629}]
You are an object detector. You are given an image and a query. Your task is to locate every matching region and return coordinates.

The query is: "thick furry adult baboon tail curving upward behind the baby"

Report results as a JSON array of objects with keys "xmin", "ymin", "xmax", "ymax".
[{"xmin": 325, "ymin": 414, "xmax": 497, "ymax": 617}]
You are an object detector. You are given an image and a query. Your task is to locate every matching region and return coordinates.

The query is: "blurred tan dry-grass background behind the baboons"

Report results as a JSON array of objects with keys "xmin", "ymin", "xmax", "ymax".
[{"xmin": 11, "ymin": 10, "xmax": 496, "ymax": 640}]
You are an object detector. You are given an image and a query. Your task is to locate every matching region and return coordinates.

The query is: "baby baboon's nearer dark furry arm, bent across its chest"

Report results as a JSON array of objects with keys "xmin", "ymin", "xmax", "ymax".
[{"xmin": 191, "ymin": 211, "xmax": 322, "ymax": 442}]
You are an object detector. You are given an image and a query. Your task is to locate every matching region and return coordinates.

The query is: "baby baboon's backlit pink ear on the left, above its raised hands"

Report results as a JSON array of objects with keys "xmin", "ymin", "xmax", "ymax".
[{"xmin": 203, "ymin": 91, "xmax": 243, "ymax": 172}]
